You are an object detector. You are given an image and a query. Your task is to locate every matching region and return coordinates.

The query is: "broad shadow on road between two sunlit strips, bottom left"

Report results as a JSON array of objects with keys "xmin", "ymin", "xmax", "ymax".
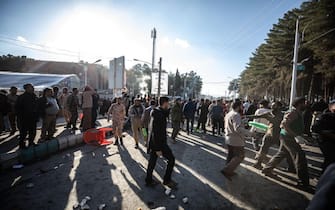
[{"xmin": 72, "ymin": 145, "xmax": 122, "ymax": 209}]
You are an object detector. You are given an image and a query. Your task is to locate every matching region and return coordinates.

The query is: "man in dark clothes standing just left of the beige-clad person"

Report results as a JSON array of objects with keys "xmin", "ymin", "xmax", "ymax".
[{"xmin": 66, "ymin": 88, "xmax": 79, "ymax": 131}]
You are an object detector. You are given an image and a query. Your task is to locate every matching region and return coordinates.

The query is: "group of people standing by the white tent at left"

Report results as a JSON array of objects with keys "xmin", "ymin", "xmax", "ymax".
[{"xmin": 0, "ymin": 84, "xmax": 99, "ymax": 149}]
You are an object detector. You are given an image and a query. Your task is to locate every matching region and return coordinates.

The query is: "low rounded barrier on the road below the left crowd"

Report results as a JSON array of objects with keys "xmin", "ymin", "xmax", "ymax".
[{"xmin": 0, "ymin": 133, "xmax": 84, "ymax": 170}]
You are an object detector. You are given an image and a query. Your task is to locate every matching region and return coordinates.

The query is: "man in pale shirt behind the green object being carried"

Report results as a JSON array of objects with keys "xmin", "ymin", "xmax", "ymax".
[{"xmin": 251, "ymin": 100, "xmax": 271, "ymax": 151}]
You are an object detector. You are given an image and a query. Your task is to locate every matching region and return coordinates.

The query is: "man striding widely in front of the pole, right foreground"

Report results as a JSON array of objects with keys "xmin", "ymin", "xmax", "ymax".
[{"xmin": 262, "ymin": 97, "xmax": 309, "ymax": 187}]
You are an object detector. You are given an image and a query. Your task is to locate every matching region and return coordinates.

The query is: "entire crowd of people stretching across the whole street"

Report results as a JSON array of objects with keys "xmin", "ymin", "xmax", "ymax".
[{"xmin": 0, "ymin": 84, "xmax": 335, "ymax": 203}]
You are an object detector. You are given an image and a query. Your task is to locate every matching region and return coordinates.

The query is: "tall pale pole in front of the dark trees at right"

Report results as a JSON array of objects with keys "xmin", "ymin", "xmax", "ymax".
[{"xmin": 290, "ymin": 17, "xmax": 300, "ymax": 108}]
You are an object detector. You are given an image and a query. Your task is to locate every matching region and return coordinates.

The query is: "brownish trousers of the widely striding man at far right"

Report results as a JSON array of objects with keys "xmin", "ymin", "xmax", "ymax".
[{"xmin": 265, "ymin": 135, "xmax": 309, "ymax": 185}]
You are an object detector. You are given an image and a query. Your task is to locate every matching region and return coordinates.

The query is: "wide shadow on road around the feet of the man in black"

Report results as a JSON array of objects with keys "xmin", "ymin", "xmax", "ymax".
[{"xmin": 120, "ymin": 139, "xmax": 247, "ymax": 210}]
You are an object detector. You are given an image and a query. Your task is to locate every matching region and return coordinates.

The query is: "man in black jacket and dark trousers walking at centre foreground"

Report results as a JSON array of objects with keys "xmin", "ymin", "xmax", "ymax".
[{"xmin": 145, "ymin": 97, "xmax": 177, "ymax": 188}]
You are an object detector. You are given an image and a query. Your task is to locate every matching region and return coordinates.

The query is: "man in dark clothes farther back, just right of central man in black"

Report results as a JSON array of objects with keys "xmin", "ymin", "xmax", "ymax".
[{"xmin": 171, "ymin": 98, "xmax": 183, "ymax": 143}]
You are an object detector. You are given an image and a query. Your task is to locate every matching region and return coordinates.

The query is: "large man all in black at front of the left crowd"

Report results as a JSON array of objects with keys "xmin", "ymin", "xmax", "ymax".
[{"xmin": 15, "ymin": 84, "xmax": 38, "ymax": 149}]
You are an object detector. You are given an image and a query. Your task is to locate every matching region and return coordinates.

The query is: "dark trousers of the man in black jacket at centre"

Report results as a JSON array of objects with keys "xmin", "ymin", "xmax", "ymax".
[{"xmin": 145, "ymin": 144, "xmax": 175, "ymax": 183}]
